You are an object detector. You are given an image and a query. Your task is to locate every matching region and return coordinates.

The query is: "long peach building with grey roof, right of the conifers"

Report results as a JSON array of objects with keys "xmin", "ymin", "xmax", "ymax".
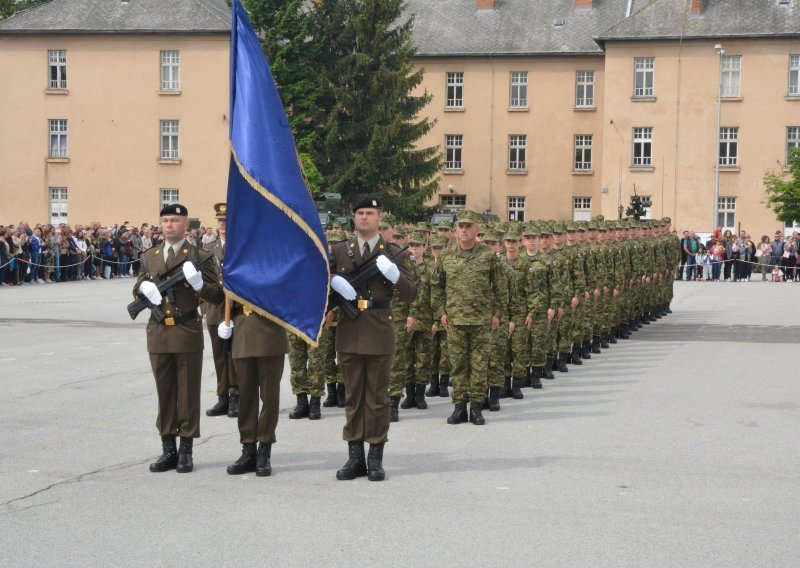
[{"xmin": 410, "ymin": 0, "xmax": 800, "ymax": 234}]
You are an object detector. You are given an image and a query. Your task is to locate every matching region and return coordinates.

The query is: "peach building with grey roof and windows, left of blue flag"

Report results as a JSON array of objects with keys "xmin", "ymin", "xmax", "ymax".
[{"xmin": 0, "ymin": 0, "xmax": 230, "ymax": 224}]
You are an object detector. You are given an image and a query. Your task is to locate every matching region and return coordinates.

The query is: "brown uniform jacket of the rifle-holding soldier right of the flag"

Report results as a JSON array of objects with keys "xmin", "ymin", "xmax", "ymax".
[{"xmin": 331, "ymin": 237, "xmax": 417, "ymax": 355}]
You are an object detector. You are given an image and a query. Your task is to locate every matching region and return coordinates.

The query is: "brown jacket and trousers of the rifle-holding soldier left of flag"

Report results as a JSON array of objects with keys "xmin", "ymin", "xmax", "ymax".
[{"xmin": 133, "ymin": 242, "xmax": 225, "ymax": 438}]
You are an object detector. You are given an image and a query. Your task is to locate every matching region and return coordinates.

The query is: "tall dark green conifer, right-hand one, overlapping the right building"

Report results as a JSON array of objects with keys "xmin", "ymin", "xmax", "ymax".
[{"xmin": 312, "ymin": 0, "xmax": 441, "ymax": 217}]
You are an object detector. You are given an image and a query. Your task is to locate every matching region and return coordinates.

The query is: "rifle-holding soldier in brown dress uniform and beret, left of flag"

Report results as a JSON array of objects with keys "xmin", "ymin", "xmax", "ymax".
[{"xmin": 133, "ymin": 203, "xmax": 224, "ymax": 473}]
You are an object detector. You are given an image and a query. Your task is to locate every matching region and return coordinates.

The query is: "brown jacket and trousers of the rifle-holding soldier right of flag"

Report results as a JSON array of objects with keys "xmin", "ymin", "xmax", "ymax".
[{"xmin": 331, "ymin": 238, "xmax": 417, "ymax": 444}]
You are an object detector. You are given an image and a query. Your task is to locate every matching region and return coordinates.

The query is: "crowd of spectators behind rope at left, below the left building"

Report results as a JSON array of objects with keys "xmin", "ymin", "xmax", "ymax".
[{"xmin": 0, "ymin": 221, "xmax": 211, "ymax": 286}]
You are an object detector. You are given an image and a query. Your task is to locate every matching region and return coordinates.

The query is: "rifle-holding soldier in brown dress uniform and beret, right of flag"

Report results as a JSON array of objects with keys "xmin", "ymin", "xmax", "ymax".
[{"xmin": 331, "ymin": 198, "xmax": 417, "ymax": 481}]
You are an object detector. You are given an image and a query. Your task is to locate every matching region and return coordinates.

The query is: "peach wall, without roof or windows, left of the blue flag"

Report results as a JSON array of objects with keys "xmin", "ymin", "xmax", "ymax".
[{"xmin": 0, "ymin": 34, "xmax": 229, "ymax": 225}]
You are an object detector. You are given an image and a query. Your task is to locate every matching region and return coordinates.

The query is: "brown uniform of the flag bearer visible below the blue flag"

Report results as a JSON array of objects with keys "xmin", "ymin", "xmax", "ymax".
[{"xmin": 231, "ymin": 305, "xmax": 289, "ymax": 444}]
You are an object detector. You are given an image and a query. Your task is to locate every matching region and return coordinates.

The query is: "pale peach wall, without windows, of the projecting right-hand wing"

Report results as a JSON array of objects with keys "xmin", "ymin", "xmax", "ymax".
[{"xmin": 600, "ymin": 39, "xmax": 800, "ymax": 236}]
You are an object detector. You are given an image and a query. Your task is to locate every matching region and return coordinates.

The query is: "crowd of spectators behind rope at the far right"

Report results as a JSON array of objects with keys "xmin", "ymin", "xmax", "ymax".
[{"xmin": 676, "ymin": 229, "xmax": 800, "ymax": 282}]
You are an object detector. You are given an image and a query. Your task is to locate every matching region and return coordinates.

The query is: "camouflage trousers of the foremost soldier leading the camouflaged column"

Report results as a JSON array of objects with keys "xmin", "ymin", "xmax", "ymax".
[{"xmin": 447, "ymin": 324, "xmax": 491, "ymax": 404}]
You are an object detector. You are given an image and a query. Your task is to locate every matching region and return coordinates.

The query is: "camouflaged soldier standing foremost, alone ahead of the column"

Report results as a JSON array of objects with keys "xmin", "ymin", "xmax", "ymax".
[{"xmin": 431, "ymin": 211, "xmax": 513, "ymax": 425}]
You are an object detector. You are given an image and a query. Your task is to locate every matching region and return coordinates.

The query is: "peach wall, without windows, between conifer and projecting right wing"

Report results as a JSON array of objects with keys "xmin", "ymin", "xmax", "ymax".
[{"xmin": 417, "ymin": 56, "xmax": 604, "ymax": 219}]
